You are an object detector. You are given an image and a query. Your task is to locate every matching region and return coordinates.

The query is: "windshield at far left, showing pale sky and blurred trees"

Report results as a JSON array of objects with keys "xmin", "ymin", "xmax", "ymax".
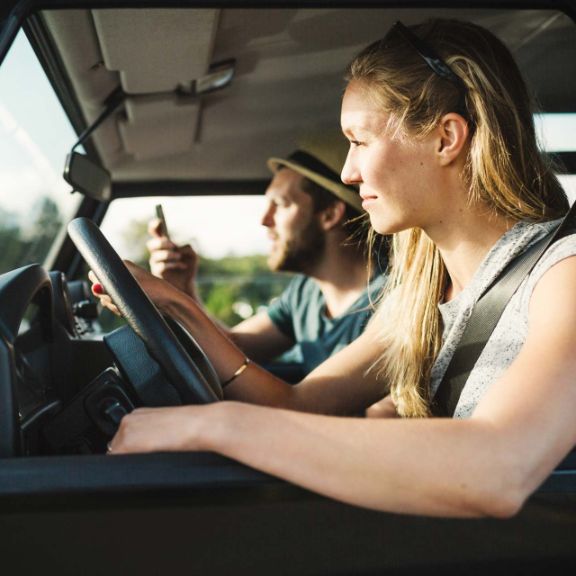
[{"xmin": 0, "ymin": 32, "xmax": 81, "ymax": 273}]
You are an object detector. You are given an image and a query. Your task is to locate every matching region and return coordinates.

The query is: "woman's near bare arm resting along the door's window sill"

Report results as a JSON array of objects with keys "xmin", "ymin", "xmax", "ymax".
[{"xmin": 112, "ymin": 258, "xmax": 576, "ymax": 517}]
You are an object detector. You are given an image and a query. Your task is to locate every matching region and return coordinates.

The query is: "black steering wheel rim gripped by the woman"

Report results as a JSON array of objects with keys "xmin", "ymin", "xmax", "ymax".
[{"xmin": 68, "ymin": 218, "xmax": 222, "ymax": 404}]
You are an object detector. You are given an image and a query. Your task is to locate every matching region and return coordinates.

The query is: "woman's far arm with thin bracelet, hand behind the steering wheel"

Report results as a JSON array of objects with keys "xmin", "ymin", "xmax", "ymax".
[{"xmin": 89, "ymin": 262, "xmax": 385, "ymax": 414}]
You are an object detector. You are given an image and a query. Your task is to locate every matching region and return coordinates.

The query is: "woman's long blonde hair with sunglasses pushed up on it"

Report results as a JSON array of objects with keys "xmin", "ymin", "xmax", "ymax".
[{"xmin": 347, "ymin": 20, "xmax": 568, "ymax": 417}]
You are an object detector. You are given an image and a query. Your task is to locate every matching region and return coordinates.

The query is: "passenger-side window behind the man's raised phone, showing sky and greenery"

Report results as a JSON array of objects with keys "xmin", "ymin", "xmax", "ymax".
[{"xmin": 102, "ymin": 195, "xmax": 290, "ymax": 326}]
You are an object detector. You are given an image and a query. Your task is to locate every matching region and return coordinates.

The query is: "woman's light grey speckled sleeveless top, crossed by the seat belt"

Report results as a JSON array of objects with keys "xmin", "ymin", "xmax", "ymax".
[{"xmin": 430, "ymin": 220, "xmax": 576, "ymax": 418}]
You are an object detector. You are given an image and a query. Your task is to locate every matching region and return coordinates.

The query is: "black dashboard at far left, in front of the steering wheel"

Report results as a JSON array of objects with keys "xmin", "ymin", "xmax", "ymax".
[{"xmin": 0, "ymin": 264, "xmax": 113, "ymax": 456}]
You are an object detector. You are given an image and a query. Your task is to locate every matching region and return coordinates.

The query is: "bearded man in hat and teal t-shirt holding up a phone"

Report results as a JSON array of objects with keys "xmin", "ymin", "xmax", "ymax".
[{"xmin": 148, "ymin": 136, "xmax": 384, "ymax": 380}]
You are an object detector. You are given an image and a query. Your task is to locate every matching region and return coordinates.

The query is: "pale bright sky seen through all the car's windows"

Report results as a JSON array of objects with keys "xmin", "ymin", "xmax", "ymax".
[{"xmin": 0, "ymin": 33, "xmax": 576, "ymax": 258}]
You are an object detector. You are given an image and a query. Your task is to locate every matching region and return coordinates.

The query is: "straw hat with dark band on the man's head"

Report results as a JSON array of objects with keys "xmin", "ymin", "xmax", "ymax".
[{"xmin": 268, "ymin": 133, "xmax": 362, "ymax": 212}]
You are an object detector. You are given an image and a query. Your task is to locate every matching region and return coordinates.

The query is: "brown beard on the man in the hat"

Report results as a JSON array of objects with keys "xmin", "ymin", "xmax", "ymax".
[{"xmin": 268, "ymin": 218, "xmax": 326, "ymax": 274}]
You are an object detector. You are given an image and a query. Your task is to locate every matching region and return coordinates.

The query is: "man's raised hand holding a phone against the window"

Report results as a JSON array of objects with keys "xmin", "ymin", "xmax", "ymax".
[{"xmin": 146, "ymin": 218, "xmax": 199, "ymax": 299}]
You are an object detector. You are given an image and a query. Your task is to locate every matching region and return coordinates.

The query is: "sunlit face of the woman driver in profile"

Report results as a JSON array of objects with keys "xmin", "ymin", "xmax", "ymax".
[{"xmin": 341, "ymin": 82, "xmax": 440, "ymax": 234}]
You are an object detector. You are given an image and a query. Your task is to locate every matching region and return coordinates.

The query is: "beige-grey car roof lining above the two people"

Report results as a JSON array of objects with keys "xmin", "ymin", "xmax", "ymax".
[{"xmin": 29, "ymin": 8, "xmax": 576, "ymax": 196}]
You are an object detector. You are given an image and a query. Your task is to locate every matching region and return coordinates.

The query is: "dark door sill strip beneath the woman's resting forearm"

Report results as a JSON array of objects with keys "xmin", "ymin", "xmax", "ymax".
[{"xmin": 0, "ymin": 452, "xmax": 576, "ymax": 501}]
